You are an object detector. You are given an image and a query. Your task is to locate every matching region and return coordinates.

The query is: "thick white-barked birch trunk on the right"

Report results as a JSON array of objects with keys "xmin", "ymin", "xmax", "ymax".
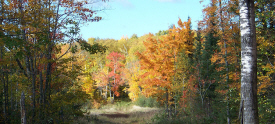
[{"xmin": 239, "ymin": 0, "xmax": 259, "ymax": 124}]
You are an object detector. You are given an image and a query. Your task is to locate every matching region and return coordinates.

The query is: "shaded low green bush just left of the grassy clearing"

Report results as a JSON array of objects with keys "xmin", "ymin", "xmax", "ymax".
[{"xmin": 41, "ymin": 86, "xmax": 89, "ymax": 123}]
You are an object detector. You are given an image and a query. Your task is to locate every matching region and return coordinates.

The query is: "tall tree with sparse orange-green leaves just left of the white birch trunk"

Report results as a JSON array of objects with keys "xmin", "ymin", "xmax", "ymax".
[{"xmin": 207, "ymin": 0, "xmax": 240, "ymax": 124}]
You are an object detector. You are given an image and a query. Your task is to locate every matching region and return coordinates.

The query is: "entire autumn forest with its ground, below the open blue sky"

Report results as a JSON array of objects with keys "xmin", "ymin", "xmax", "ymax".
[{"xmin": 0, "ymin": 0, "xmax": 275, "ymax": 124}]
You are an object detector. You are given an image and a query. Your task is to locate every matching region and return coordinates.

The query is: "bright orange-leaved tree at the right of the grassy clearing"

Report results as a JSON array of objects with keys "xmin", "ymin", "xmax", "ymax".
[{"xmin": 137, "ymin": 19, "xmax": 194, "ymax": 117}]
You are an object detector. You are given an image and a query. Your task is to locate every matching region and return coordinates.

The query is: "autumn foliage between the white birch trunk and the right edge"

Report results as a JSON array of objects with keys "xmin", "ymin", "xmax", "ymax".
[{"xmin": 255, "ymin": 0, "xmax": 275, "ymax": 123}]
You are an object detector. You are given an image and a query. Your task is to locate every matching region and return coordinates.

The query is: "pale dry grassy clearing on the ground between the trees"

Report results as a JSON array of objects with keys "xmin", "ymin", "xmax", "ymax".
[{"xmin": 75, "ymin": 101, "xmax": 161, "ymax": 124}]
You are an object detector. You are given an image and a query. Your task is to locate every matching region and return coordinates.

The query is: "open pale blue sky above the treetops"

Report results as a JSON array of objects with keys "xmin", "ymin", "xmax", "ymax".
[{"xmin": 80, "ymin": 0, "xmax": 209, "ymax": 40}]
